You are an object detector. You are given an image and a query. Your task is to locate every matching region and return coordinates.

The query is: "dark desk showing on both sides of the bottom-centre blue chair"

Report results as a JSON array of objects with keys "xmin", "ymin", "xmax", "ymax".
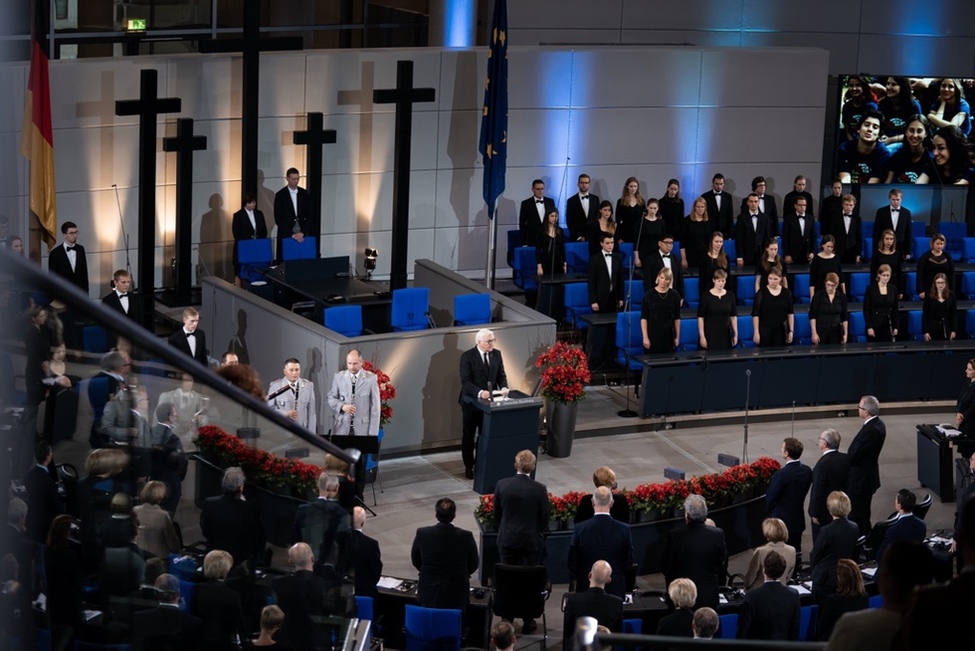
[{"xmin": 373, "ymin": 577, "xmax": 494, "ymax": 649}]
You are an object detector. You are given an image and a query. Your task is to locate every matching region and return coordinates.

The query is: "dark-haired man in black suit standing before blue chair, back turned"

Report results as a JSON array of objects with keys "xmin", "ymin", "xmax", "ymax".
[{"xmin": 410, "ymin": 497, "xmax": 480, "ymax": 610}]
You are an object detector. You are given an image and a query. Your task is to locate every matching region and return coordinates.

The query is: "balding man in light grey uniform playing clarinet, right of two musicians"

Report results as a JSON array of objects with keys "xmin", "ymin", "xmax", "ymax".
[{"xmin": 327, "ymin": 349, "xmax": 379, "ymax": 500}]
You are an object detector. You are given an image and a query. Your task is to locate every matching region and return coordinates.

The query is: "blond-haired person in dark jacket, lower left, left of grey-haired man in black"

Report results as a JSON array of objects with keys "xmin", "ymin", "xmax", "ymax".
[{"xmin": 192, "ymin": 549, "xmax": 246, "ymax": 651}]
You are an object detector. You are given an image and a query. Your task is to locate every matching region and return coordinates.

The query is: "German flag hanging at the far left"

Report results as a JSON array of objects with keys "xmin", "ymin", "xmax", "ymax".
[{"xmin": 20, "ymin": 0, "xmax": 58, "ymax": 250}]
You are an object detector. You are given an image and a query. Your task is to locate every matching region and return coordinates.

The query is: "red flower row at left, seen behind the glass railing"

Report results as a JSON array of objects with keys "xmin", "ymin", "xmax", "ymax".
[{"xmin": 193, "ymin": 425, "xmax": 322, "ymax": 497}]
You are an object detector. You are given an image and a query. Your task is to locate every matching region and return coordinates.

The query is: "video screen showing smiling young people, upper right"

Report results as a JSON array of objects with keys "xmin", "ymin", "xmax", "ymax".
[{"xmin": 833, "ymin": 75, "xmax": 975, "ymax": 186}]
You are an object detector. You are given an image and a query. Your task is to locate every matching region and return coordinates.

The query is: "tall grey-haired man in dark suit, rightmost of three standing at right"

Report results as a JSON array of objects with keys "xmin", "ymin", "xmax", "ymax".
[{"xmin": 846, "ymin": 396, "xmax": 887, "ymax": 534}]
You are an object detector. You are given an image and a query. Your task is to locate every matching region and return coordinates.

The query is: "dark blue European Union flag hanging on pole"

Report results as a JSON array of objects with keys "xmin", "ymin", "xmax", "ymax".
[{"xmin": 478, "ymin": 0, "xmax": 508, "ymax": 219}]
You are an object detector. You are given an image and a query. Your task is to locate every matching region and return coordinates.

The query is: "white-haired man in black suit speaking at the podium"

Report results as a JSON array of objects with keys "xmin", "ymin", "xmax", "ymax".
[{"xmin": 458, "ymin": 328, "xmax": 508, "ymax": 479}]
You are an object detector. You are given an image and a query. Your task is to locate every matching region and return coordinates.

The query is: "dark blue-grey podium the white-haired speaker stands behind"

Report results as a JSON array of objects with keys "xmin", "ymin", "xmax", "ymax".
[{"xmin": 465, "ymin": 391, "xmax": 542, "ymax": 495}]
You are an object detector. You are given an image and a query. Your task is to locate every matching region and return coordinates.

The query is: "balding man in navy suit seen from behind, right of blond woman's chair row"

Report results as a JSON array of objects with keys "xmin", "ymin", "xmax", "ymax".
[{"xmin": 569, "ymin": 486, "xmax": 633, "ymax": 599}]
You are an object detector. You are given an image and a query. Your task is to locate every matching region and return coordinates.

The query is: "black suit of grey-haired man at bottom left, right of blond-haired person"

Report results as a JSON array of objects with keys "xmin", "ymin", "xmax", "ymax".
[{"xmin": 271, "ymin": 570, "xmax": 334, "ymax": 649}]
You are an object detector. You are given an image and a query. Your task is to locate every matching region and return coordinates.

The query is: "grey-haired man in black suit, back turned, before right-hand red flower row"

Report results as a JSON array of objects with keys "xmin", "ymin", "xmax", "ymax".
[{"xmin": 660, "ymin": 495, "xmax": 728, "ymax": 609}]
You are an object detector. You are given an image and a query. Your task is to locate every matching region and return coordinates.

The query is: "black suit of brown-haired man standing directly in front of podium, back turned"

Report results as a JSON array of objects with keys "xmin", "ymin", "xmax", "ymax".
[{"xmin": 494, "ymin": 473, "xmax": 550, "ymax": 565}]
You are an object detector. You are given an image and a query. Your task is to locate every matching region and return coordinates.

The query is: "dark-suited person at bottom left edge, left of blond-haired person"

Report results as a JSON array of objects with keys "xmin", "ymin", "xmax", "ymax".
[{"xmin": 132, "ymin": 574, "xmax": 204, "ymax": 651}]
